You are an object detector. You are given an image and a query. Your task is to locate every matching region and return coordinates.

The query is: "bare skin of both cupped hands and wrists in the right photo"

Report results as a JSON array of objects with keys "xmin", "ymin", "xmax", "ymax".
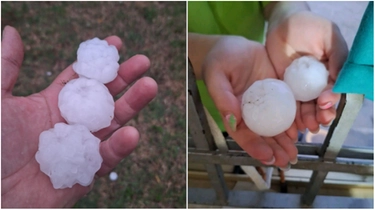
[{"xmin": 188, "ymin": 2, "xmax": 348, "ymax": 169}]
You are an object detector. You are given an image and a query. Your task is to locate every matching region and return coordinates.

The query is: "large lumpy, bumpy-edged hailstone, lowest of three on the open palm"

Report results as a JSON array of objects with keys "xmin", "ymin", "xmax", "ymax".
[{"xmin": 35, "ymin": 123, "xmax": 103, "ymax": 189}]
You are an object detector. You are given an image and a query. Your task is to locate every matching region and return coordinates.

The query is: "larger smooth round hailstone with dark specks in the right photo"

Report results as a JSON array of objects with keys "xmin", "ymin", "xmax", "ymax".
[{"xmin": 242, "ymin": 79, "xmax": 297, "ymax": 137}]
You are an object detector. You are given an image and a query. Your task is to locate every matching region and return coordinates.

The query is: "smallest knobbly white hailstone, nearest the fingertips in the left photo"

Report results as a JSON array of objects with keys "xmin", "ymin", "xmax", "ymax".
[{"xmin": 73, "ymin": 38, "xmax": 120, "ymax": 84}]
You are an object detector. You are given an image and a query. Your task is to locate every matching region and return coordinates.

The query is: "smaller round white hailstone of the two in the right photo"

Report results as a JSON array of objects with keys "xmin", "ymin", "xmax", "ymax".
[{"xmin": 284, "ymin": 56, "xmax": 329, "ymax": 101}]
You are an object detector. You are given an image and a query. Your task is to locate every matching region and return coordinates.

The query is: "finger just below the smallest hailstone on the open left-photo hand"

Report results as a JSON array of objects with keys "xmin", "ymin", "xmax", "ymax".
[{"xmin": 106, "ymin": 55, "xmax": 150, "ymax": 96}]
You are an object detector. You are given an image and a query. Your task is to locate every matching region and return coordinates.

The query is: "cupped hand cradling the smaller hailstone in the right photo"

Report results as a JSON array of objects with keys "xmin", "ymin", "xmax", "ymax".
[{"xmin": 266, "ymin": 11, "xmax": 348, "ymax": 133}]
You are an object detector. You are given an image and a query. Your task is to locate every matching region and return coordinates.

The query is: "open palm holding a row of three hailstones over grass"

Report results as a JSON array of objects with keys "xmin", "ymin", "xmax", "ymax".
[{"xmin": 1, "ymin": 26, "xmax": 157, "ymax": 207}]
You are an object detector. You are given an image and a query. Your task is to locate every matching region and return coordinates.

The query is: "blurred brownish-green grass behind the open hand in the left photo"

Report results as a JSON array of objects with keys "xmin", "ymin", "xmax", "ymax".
[{"xmin": 1, "ymin": 2, "xmax": 186, "ymax": 208}]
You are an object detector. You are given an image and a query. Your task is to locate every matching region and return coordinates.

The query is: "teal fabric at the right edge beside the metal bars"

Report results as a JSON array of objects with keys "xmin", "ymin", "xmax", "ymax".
[{"xmin": 333, "ymin": 1, "xmax": 374, "ymax": 101}]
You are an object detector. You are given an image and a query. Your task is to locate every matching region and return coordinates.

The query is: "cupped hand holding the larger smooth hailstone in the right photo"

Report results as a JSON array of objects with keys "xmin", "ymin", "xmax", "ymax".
[{"xmin": 202, "ymin": 36, "xmax": 298, "ymax": 168}]
